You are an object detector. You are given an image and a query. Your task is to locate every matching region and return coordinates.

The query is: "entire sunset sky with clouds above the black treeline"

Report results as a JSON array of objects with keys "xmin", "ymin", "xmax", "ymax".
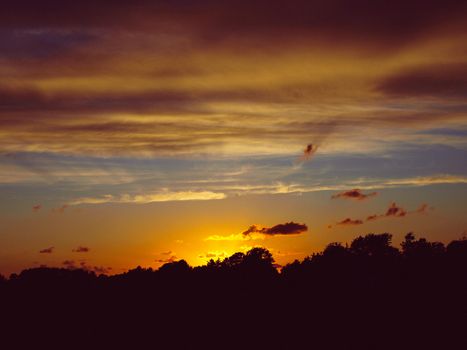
[{"xmin": 0, "ymin": 0, "xmax": 467, "ymax": 274}]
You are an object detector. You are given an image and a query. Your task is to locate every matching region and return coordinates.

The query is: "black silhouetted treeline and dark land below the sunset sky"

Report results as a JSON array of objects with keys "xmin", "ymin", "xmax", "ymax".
[{"xmin": 0, "ymin": 234, "xmax": 467, "ymax": 349}]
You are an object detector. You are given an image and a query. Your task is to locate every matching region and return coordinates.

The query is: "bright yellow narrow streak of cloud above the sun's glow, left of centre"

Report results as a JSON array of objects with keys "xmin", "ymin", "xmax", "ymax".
[{"xmin": 70, "ymin": 191, "xmax": 226, "ymax": 205}]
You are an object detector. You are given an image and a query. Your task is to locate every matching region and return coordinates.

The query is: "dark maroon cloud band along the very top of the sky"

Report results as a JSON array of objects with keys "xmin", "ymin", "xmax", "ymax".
[{"xmin": 0, "ymin": 0, "xmax": 466, "ymax": 50}]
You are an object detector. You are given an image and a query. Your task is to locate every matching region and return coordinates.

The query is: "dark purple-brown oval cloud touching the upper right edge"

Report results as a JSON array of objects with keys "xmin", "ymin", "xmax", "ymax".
[{"xmin": 377, "ymin": 63, "xmax": 467, "ymax": 98}]
